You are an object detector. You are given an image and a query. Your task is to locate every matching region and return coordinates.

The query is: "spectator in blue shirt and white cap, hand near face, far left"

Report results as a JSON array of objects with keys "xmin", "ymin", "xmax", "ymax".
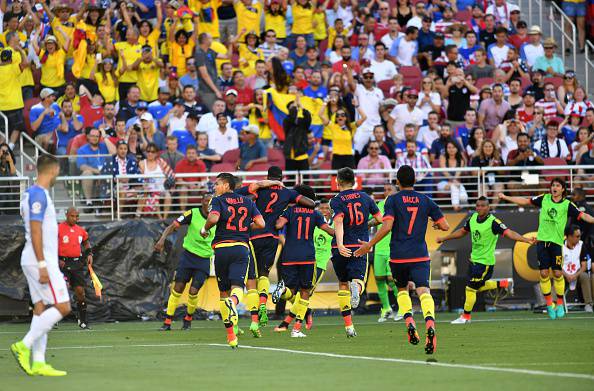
[{"xmin": 29, "ymin": 88, "xmax": 61, "ymax": 150}]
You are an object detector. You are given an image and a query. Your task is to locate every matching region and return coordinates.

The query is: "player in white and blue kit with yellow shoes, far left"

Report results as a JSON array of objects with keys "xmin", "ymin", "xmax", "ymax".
[{"xmin": 10, "ymin": 155, "xmax": 70, "ymax": 376}]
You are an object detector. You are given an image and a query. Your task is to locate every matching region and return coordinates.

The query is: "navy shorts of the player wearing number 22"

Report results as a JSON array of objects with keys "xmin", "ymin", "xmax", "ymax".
[{"xmin": 214, "ymin": 245, "xmax": 250, "ymax": 292}]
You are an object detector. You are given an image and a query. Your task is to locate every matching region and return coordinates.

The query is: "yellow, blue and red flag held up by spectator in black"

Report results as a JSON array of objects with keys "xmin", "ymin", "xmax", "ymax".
[{"xmin": 264, "ymin": 88, "xmax": 324, "ymax": 141}]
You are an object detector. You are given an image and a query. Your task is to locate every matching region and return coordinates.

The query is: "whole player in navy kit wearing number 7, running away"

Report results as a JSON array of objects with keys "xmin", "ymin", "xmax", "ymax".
[{"xmin": 355, "ymin": 165, "xmax": 450, "ymax": 354}]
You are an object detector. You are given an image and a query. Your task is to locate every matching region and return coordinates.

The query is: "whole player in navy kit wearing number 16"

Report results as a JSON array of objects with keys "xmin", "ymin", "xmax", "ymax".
[{"xmin": 330, "ymin": 167, "xmax": 382, "ymax": 338}]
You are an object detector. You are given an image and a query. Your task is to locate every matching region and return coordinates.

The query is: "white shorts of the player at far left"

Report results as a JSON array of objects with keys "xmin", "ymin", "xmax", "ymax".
[{"xmin": 21, "ymin": 265, "xmax": 70, "ymax": 305}]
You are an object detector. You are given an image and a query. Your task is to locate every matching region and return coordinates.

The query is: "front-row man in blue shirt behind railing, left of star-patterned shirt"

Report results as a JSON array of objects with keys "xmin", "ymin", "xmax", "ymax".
[{"xmin": 76, "ymin": 128, "xmax": 109, "ymax": 213}]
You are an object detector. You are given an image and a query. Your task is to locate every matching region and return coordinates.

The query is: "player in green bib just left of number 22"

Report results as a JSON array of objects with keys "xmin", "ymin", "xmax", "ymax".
[{"xmin": 155, "ymin": 193, "xmax": 213, "ymax": 331}]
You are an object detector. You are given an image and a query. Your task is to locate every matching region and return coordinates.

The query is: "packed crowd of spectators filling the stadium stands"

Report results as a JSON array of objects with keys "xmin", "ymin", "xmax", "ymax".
[{"xmin": 0, "ymin": 0, "xmax": 594, "ymax": 213}]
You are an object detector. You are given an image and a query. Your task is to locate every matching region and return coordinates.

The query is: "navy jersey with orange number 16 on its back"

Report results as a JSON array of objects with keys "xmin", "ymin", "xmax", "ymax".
[{"xmin": 330, "ymin": 190, "xmax": 381, "ymax": 247}]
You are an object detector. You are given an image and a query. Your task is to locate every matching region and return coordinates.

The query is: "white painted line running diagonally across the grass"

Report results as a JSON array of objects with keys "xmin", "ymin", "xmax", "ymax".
[{"xmin": 207, "ymin": 343, "xmax": 594, "ymax": 381}]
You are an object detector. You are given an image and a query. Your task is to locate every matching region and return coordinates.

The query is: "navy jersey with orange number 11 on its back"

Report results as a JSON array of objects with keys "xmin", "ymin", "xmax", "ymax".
[{"xmin": 280, "ymin": 206, "xmax": 327, "ymax": 264}]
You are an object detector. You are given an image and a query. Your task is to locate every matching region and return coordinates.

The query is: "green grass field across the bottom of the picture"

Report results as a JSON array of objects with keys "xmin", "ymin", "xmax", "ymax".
[{"xmin": 0, "ymin": 312, "xmax": 594, "ymax": 391}]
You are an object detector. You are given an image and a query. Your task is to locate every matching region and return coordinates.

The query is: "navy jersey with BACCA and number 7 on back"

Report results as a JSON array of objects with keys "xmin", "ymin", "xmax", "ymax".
[{"xmin": 384, "ymin": 190, "xmax": 443, "ymax": 263}]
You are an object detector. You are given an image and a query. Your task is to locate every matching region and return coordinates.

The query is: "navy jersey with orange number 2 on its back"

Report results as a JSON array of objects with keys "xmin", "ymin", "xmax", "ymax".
[{"xmin": 235, "ymin": 186, "xmax": 301, "ymax": 239}]
